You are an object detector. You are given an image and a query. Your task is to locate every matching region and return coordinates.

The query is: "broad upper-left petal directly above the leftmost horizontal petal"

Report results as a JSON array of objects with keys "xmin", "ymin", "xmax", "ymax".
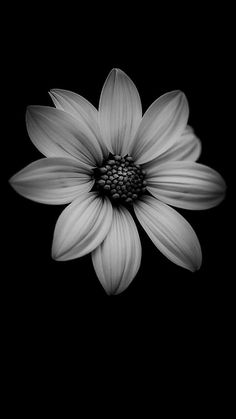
[{"xmin": 26, "ymin": 106, "xmax": 102, "ymax": 166}]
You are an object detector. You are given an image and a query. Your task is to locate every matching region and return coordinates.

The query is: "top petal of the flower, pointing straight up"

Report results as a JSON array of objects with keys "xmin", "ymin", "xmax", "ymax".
[{"xmin": 99, "ymin": 69, "xmax": 142, "ymax": 155}]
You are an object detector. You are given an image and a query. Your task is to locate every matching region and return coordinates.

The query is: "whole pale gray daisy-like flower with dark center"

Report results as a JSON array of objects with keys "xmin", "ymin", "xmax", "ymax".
[{"xmin": 10, "ymin": 69, "xmax": 225, "ymax": 294}]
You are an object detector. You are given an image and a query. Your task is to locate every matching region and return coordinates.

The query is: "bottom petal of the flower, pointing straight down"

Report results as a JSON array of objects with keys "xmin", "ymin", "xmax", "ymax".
[{"xmin": 92, "ymin": 207, "xmax": 142, "ymax": 294}]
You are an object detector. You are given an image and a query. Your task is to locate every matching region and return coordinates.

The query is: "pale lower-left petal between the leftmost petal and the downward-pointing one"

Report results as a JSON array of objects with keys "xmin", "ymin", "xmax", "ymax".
[{"xmin": 52, "ymin": 192, "xmax": 112, "ymax": 260}]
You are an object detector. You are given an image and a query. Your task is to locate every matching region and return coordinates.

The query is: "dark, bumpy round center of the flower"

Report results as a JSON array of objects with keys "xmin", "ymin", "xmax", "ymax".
[{"xmin": 95, "ymin": 154, "xmax": 147, "ymax": 204}]
